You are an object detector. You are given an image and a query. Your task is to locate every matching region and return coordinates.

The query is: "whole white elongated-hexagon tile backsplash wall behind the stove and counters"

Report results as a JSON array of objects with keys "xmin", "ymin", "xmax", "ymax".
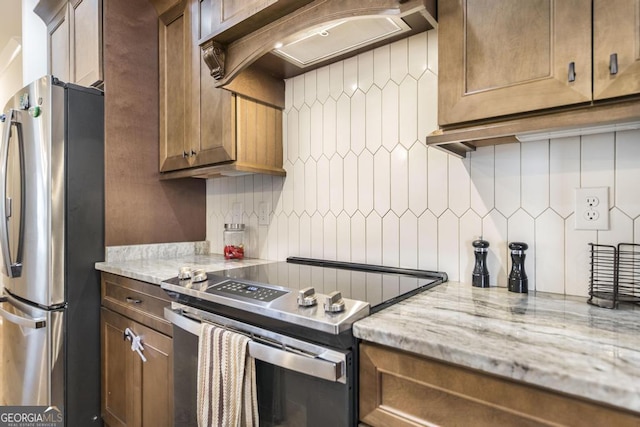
[{"xmin": 207, "ymin": 31, "xmax": 640, "ymax": 295}]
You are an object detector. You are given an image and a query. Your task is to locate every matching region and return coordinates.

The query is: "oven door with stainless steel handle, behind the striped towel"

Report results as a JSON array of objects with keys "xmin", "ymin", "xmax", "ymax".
[{"xmin": 165, "ymin": 303, "xmax": 356, "ymax": 427}]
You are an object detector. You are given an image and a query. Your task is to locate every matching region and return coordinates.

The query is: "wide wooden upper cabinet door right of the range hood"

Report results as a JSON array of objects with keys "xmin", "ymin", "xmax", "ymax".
[{"xmin": 438, "ymin": 0, "xmax": 591, "ymax": 126}]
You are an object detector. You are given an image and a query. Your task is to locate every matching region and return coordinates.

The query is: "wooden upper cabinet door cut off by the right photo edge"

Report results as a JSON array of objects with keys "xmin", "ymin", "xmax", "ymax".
[{"xmin": 593, "ymin": 0, "xmax": 640, "ymax": 99}]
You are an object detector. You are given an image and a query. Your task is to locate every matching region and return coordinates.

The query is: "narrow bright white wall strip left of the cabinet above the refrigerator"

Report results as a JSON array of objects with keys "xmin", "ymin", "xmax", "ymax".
[{"xmin": 22, "ymin": 0, "xmax": 47, "ymax": 85}]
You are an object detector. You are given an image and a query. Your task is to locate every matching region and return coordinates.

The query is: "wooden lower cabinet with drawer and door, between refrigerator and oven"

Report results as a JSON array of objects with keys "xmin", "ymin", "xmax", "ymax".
[{"xmin": 100, "ymin": 273, "xmax": 173, "ymax": 427}]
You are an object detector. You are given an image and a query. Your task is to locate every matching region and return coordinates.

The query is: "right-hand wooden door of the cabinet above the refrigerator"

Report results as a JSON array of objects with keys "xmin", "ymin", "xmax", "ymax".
[{"xmin": 70, "ymin": 0, "xmax": 103, "ymax": 86}]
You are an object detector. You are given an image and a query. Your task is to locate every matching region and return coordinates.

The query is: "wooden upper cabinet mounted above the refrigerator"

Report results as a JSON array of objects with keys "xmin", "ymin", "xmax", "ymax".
[{"xmin": 34, "ymin": 0, "xmax": 104, "ymax": 86}]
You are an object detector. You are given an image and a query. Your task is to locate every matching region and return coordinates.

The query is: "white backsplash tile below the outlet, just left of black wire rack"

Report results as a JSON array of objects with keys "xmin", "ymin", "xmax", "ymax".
[{"xmin": 564, "ymin": 213, "xmax": 598, "ymax": 297}]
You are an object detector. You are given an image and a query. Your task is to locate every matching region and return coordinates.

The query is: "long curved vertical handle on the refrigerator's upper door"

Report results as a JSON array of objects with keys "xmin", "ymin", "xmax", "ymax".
[{"xmin": 0, "ymin": 109, "xmax": 25, "ymax": 277}]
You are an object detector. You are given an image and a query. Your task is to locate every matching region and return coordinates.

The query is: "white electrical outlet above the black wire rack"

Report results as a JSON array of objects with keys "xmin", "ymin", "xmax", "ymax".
[{"xmin": 575, "ymin": 187, "xmax": 609, "ymax": 230}]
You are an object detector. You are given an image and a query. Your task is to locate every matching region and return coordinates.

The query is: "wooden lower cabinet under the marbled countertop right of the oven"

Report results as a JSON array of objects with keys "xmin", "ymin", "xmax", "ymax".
[{"xmin": 360, "ymin": 343, "xmax": 640, "ymax": 427}]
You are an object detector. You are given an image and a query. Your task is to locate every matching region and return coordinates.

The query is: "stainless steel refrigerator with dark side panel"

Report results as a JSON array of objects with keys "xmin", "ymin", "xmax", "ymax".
[{"xmin": 0, "ymin": 76, "xmax": 104, "ymax": 427}]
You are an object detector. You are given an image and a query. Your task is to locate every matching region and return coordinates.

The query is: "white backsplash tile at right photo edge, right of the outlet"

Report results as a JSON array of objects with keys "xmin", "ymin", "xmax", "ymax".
[{"xmin": 615, "ymin": 130, "xmax": 640, "ymax": 218}]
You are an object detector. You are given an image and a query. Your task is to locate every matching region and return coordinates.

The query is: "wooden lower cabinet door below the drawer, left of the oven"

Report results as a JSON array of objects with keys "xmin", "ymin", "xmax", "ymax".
[{"xmin": 101, "ymin": 308, "xmax": 173, "ymax": 427}]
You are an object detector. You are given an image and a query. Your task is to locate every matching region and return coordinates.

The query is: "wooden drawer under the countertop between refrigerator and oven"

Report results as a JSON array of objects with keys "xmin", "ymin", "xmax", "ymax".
[{"xmin": 102, "ymin": 273, "xmax": 172, "ymax": 336}]
